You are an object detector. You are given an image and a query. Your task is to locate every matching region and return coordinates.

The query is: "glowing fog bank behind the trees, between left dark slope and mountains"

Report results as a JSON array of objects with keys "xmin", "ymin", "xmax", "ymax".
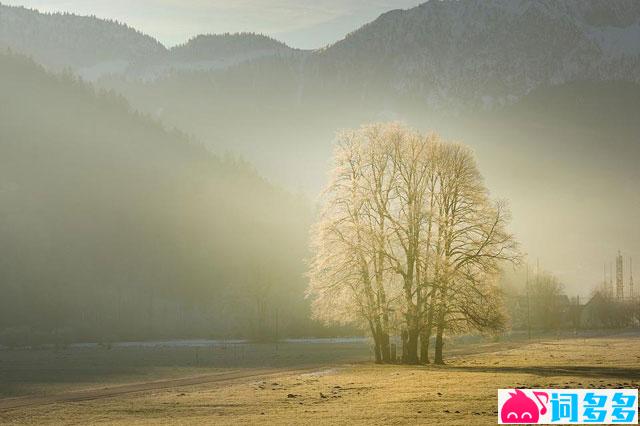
[{"xmin": 103, "ymin": 69, "xmax": 640, "ymax": 298}]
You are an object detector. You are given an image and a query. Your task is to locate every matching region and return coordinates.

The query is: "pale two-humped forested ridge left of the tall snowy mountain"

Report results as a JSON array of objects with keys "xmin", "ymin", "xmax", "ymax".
[{"xmin": 0, "ymin": 4, "xmax": 296, "ymax": 81}]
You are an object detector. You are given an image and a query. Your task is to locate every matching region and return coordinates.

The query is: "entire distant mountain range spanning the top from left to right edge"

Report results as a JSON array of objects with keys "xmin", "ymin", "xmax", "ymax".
[{"xmin": 6, "ymin": 0, "xmax": 640, "ymax": 102}]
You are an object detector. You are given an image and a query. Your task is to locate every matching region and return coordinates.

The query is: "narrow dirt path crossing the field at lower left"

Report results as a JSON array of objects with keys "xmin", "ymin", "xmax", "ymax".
[{"xmin": 0, "ymin": 366, "xmax": 319, "ymax": 411}]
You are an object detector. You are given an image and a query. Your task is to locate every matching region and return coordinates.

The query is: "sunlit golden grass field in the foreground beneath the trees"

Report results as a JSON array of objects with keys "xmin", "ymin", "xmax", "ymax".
[{"xmin": 0, "ymin": 334, "xmax": 640, "ymax": 425}]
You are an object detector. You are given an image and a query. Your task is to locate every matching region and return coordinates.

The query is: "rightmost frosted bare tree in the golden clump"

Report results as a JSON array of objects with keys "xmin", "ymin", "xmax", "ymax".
[{"xmin": 434, "ymin": 144, "xmax": 519, "ymax": 363}]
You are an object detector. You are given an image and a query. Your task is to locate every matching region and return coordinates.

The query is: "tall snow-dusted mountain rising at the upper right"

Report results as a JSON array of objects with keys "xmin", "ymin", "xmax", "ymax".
[{"xmin": 313, "ymin": 0, "xmax": 640, "ymax": 109}]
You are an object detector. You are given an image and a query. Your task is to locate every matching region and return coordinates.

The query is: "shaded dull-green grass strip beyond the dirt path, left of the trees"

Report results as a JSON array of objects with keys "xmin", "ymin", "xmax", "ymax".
[{"xmin": 0, "ymin": 339, "xmax": 369, "ymax": 398}]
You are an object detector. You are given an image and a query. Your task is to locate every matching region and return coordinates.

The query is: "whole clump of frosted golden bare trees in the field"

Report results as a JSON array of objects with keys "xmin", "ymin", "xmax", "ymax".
[{"xmin": 308, "ymin": 123, "xmax": 519, "ymax": 364}]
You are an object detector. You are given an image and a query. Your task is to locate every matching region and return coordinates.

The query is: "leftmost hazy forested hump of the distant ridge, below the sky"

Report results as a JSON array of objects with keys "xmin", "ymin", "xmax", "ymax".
[{"xmin": 0, "ymin": 4, "xmax": 166, "ymax": 79}]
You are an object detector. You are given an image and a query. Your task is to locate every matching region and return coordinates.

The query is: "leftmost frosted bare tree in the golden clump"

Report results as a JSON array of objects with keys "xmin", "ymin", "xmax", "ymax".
[{"xmin": 307, "ymin": 132, "xmax": 392, "ymax": 362}]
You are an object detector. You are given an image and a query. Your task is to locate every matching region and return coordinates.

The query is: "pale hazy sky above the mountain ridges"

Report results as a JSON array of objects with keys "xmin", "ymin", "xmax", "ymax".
[{"xmin": 1, "ymin": 0, "xmax": 421, "ymax": 48}]
